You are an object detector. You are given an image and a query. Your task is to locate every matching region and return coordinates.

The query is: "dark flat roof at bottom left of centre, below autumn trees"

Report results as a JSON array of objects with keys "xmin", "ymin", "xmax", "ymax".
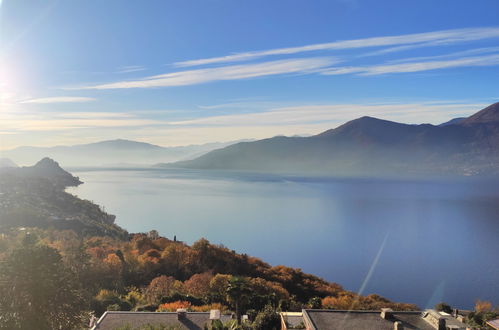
[{"xmin": 94, "ymin": 312, "xmax": 230, "ymax": 330}]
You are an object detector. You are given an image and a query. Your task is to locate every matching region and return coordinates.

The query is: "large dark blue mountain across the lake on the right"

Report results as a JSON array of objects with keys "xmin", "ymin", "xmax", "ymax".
[{"xmin": 163, "ymin": 103, "xmax": 499, "ymax": 176}]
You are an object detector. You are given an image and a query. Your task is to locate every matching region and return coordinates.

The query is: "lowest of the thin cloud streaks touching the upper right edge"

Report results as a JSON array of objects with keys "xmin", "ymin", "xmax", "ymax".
[{"xmin": 322, "ymin": 54, "xmax": 499, "ymax": 76}]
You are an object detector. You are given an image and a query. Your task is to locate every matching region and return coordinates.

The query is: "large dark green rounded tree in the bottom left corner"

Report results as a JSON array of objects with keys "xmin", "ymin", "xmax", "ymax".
[{"xmin": 0, "ymin": 241, "xmax": 86, "ymax": 330}]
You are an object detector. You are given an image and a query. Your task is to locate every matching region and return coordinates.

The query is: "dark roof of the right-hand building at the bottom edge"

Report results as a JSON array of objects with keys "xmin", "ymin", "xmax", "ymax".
[{"xmin": 303, "ymin": 309, "xmax": 434, "ymax": 330}]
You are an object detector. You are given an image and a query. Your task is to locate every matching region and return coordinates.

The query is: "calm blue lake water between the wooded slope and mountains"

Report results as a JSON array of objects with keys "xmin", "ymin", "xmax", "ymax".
[{"xmin": 70, "ymin": 169, "xmax": 499, "ymax": 308}]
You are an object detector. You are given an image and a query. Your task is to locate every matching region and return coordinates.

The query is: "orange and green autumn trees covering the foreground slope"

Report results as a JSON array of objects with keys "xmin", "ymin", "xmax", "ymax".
[{"xmin": 0, "ymin": 228, "xmax": 416, "ymax": 329}]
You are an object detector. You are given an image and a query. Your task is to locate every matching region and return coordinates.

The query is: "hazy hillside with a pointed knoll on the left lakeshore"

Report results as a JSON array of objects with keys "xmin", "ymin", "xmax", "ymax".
[{"xmin": 0, "ymin": 158, "xmax": 127, "ymax": 237}]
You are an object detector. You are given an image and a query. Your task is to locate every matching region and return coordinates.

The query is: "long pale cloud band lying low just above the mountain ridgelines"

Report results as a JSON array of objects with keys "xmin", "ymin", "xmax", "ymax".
[{"xmin": 0, "ymin": 100, "xmax": 492, "ymax": 149}]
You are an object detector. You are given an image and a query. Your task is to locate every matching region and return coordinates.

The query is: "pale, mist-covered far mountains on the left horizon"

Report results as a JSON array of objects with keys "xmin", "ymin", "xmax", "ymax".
[{"xmin": 3, "ymin": 139, "xmax": 240, "ymax": 167}]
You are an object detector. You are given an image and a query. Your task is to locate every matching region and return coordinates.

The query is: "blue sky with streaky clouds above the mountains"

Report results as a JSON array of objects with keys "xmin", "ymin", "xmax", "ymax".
[{"xmin": 0, "ymin": 0, "xmax": 499, "ymax": 150}]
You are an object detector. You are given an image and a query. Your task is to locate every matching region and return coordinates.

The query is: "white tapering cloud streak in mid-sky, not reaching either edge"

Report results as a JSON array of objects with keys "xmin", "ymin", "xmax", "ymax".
[{"xmin": 74, "ymin": 57, "xmax": 338, "ymax": 89}]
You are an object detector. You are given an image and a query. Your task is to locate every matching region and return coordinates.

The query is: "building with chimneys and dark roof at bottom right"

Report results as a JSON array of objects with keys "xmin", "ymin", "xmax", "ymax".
[{"xmin": 281, "ymin": 308, "xmax": 468, "ymax": 330}]
